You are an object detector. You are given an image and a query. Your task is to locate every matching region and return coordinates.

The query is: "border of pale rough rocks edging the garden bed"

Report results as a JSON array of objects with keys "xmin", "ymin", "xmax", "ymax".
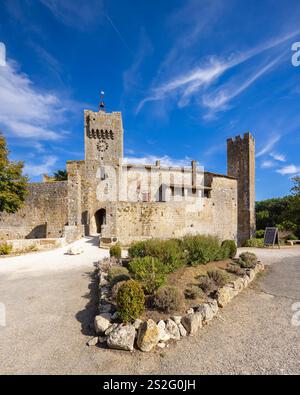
[{"xmin": 87, "ymin": 261, "xmax": 265, "ymax": 352}]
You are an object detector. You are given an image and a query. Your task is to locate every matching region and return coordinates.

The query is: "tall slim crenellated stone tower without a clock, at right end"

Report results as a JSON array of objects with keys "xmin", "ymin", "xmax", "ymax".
[{"xmin": 227, "ymin": 133, "xmax": 256, "ymax": 246}]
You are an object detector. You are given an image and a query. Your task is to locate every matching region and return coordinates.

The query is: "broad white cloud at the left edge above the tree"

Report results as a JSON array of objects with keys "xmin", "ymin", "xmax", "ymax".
[{"xmin": 0, "ymin": 61, "xmax": 66, "ymax": 140}]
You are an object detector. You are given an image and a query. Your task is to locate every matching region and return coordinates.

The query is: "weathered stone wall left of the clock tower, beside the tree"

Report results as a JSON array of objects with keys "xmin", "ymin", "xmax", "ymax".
[{"xmin": 0, "ymin": 181, "xmax": 68, "ymax": 240}]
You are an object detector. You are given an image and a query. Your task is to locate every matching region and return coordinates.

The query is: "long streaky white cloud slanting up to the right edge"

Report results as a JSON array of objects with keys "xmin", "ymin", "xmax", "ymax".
[{"xmin": 136, "ymin": 30, "xmax": 299, "ymax": 113}]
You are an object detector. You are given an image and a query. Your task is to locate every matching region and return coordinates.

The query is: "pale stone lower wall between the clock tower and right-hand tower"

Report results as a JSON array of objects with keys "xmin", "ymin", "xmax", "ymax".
[{"xmin": 111, "ymin": 175, "xmax": 237, "ymax": 245}]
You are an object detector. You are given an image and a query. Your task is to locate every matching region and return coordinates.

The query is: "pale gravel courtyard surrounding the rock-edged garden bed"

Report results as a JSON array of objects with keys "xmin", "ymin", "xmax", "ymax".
[{"xmin": 0, "ymin": 238, "xmax": 300, "ymax": 374}]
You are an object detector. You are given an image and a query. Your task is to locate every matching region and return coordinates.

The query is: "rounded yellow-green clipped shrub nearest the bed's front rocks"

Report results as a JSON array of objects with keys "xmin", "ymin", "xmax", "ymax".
[{"xmin": 117, "ymin": 280, "xmax": 145, "ymax": 322}]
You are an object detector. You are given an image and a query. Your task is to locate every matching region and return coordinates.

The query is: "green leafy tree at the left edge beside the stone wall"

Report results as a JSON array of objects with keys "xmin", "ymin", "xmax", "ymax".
[{"xmin": 0, "ymin": 133, "xmax": 28, "ymax": 213}]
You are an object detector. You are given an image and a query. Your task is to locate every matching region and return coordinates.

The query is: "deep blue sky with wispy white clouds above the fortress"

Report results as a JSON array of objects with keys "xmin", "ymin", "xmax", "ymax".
[{"xmin": 0, "ymin": 0, "xmax": 300, "ymax": 200}]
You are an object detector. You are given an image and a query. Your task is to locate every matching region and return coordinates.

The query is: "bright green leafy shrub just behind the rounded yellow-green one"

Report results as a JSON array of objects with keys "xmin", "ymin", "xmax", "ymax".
[{"xmin": 129, "ymin": 256, "xmax": 165, "ymax": 295}]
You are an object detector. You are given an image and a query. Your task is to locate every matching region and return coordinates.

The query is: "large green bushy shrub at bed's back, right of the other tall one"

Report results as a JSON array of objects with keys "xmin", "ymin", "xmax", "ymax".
[{"xmin": 183, "ymin": 235, "xmax": 224, "ymax": 266}]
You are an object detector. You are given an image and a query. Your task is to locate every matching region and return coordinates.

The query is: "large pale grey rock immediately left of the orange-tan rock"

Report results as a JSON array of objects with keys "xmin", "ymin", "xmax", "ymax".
[{"xmin": 107, "ymin": 324, "xmax": 135, "ymax": 351}]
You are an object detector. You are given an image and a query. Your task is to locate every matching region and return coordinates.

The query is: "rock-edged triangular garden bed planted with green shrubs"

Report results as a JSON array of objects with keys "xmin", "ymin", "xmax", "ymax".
[{"xmin": 88, "ymin": 235, "xmax": 263, "ymax": 351}]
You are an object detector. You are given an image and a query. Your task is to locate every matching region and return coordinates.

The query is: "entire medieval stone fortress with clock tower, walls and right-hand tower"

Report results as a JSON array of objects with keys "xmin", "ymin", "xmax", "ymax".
[{"xmin": 0, "ymin": 105, "xmax": 255, "ymax": 246}]
